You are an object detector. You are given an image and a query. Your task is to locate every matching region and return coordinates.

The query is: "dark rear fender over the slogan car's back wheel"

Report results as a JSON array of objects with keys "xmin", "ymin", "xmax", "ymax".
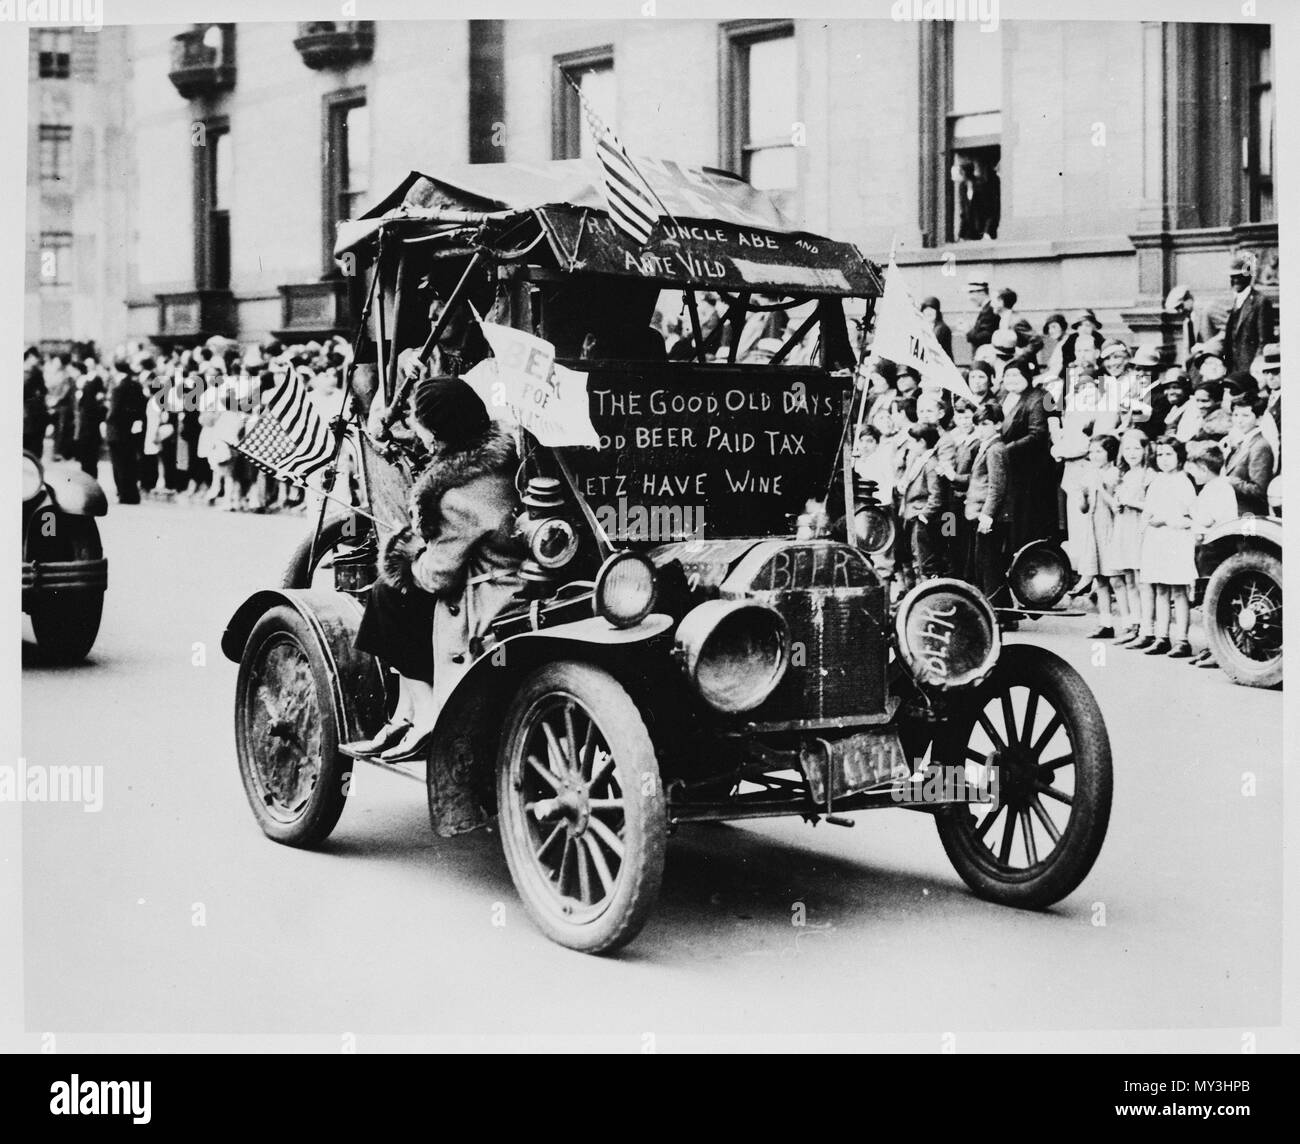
[{"xmin": 221, "ymin": 588, "xmax": 385, "ymax": 741}]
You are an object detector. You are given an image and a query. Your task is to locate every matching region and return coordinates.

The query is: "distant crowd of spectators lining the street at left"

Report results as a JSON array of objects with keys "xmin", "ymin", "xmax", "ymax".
[{"xmin": 22, "ymin": 330, "xmax": 351, "ymax": 512}]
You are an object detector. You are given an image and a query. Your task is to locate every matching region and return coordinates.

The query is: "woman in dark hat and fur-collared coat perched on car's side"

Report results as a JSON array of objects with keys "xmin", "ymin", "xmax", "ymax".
[{"xmin": 351, "ymin": 377, "xmax": 524, "ymax": 762}]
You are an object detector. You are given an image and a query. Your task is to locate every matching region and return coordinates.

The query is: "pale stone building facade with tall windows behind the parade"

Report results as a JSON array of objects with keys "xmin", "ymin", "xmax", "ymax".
[{"xmin": 32, "ymin": 20, "xmax": 1277, "ymax": 361}]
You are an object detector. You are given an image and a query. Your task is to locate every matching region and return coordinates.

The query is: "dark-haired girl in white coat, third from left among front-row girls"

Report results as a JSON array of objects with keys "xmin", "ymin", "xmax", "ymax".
[{"xmin": 1140, "ymin": 437, "xmax": 1196, "ymax": 659}]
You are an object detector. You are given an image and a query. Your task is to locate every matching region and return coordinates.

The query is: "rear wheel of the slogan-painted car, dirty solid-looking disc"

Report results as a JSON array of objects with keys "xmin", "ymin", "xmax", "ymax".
[{"xmin": 235, "ymin": 606, "xmax": 352, "ymax": 848}]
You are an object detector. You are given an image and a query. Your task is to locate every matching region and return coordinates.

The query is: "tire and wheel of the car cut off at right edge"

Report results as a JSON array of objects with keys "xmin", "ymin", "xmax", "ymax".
[{"xmin": 1201, "ymin": 549, "xmax": 1282, "ymax": 688}]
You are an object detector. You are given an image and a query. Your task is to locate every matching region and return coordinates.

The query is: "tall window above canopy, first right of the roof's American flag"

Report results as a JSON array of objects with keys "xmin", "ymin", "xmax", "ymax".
[{"xmin": 722, "ymin": 21, "xmax": 800, "ymax": 215}]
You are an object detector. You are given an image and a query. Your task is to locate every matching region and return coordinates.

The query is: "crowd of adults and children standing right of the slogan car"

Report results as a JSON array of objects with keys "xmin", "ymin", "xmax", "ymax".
[{"xmin": 854, "ymin": 255, "xmax": 1282, "ymax": 667}]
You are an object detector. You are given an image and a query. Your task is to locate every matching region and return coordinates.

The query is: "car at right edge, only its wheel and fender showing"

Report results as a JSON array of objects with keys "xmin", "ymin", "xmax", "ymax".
[{"xmin": 1196, "ymin": 477, "xmax": 1282, "ymax": 688}]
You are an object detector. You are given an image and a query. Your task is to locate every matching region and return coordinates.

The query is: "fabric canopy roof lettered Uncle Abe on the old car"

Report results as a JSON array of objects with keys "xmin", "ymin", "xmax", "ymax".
[{"xmin": 334, "ymin": 159, "xmax": 881, "ymax": 298}]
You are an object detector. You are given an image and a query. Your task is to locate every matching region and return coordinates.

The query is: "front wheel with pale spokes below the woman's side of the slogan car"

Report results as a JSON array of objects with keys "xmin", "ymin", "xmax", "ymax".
[{"xmin": 497, "ymin": 660, "xmax": 668, "ymax": 953}]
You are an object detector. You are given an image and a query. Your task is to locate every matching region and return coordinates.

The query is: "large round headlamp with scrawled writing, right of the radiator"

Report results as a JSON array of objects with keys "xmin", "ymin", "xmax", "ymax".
[{"xmin": 894, "ymin": 579, "xmax": 1002, "ymax": 690}]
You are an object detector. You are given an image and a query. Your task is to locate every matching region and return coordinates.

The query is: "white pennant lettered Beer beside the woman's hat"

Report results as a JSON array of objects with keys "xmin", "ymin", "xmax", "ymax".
[{"xmin": 464, "ymin": 321, "xmax": 601, "ymax": 447}]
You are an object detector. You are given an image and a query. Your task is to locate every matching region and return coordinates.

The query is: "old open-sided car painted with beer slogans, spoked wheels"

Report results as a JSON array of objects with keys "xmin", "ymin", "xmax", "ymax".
[{"xmin": 222, "ymin": 160, "xmax": 1112, "ymax": 953}]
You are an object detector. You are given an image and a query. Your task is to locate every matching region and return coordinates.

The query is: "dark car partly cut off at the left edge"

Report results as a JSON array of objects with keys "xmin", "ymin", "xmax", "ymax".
[{"xmin": 22, "ymin": 452, "xmax": 108, "ymax": 663}]
